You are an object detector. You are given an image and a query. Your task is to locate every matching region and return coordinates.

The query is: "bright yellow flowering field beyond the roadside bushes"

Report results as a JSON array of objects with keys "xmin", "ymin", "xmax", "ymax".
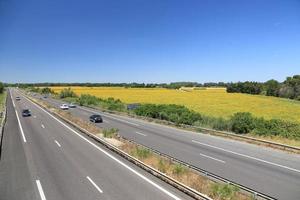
[{"xmin": 51, "ymin": 87, "xmax": 300, "ymax": 122}]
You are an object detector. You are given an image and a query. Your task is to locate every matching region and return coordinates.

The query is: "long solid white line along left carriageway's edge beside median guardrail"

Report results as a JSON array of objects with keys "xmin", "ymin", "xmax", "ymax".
[{"xmin": 24, "ymin": 96, "xmax": 181, "ymax": 200}]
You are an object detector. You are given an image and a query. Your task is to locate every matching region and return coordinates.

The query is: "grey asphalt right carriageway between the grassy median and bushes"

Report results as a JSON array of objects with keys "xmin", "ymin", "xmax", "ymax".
[{"xmin": 32, "ymin": 91, "xmax": 300, "ymax": 200}]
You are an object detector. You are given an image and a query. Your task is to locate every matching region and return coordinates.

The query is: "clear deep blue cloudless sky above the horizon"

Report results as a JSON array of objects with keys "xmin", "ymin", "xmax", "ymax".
[{"xmin": 0, "ymin": 0, "xmax": 300, "ymax": 83}]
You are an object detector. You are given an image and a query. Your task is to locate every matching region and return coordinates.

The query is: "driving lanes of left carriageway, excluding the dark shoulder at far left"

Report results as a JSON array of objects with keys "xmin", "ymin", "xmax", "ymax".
[{"xmin": 8, "ymin": 90, "xmax": 190, "ymax": 200}]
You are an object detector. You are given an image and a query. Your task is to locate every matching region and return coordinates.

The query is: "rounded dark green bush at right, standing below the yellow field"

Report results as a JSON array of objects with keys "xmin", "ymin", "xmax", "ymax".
[{"xmin": 230, "ymin": 112, "xmax": 255, "ymax": 134}]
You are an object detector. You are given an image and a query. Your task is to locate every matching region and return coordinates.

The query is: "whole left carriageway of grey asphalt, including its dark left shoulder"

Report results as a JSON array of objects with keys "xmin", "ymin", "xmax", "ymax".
[{"xmin": 0, "ymin": 91, "xmax": 190, "ymax": 200}]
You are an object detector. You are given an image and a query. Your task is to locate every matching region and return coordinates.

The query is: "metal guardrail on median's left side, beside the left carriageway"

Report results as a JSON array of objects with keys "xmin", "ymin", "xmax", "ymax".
[{"xmin": 27, "ymin": 93, "xmax": 212, "ymax": 200}]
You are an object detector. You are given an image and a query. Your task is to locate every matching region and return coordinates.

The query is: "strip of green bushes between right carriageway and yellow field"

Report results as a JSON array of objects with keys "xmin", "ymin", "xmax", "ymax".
[{"xmin": 28, "ymin": 88, "xmax": 300, "ymax": 144}]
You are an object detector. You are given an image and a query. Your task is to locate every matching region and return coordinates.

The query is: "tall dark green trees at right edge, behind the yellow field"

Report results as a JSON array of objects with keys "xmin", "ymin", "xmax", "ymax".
[{"xmin": 227, "ymin": 75, "xmax": 300, "ymax": 100}]
